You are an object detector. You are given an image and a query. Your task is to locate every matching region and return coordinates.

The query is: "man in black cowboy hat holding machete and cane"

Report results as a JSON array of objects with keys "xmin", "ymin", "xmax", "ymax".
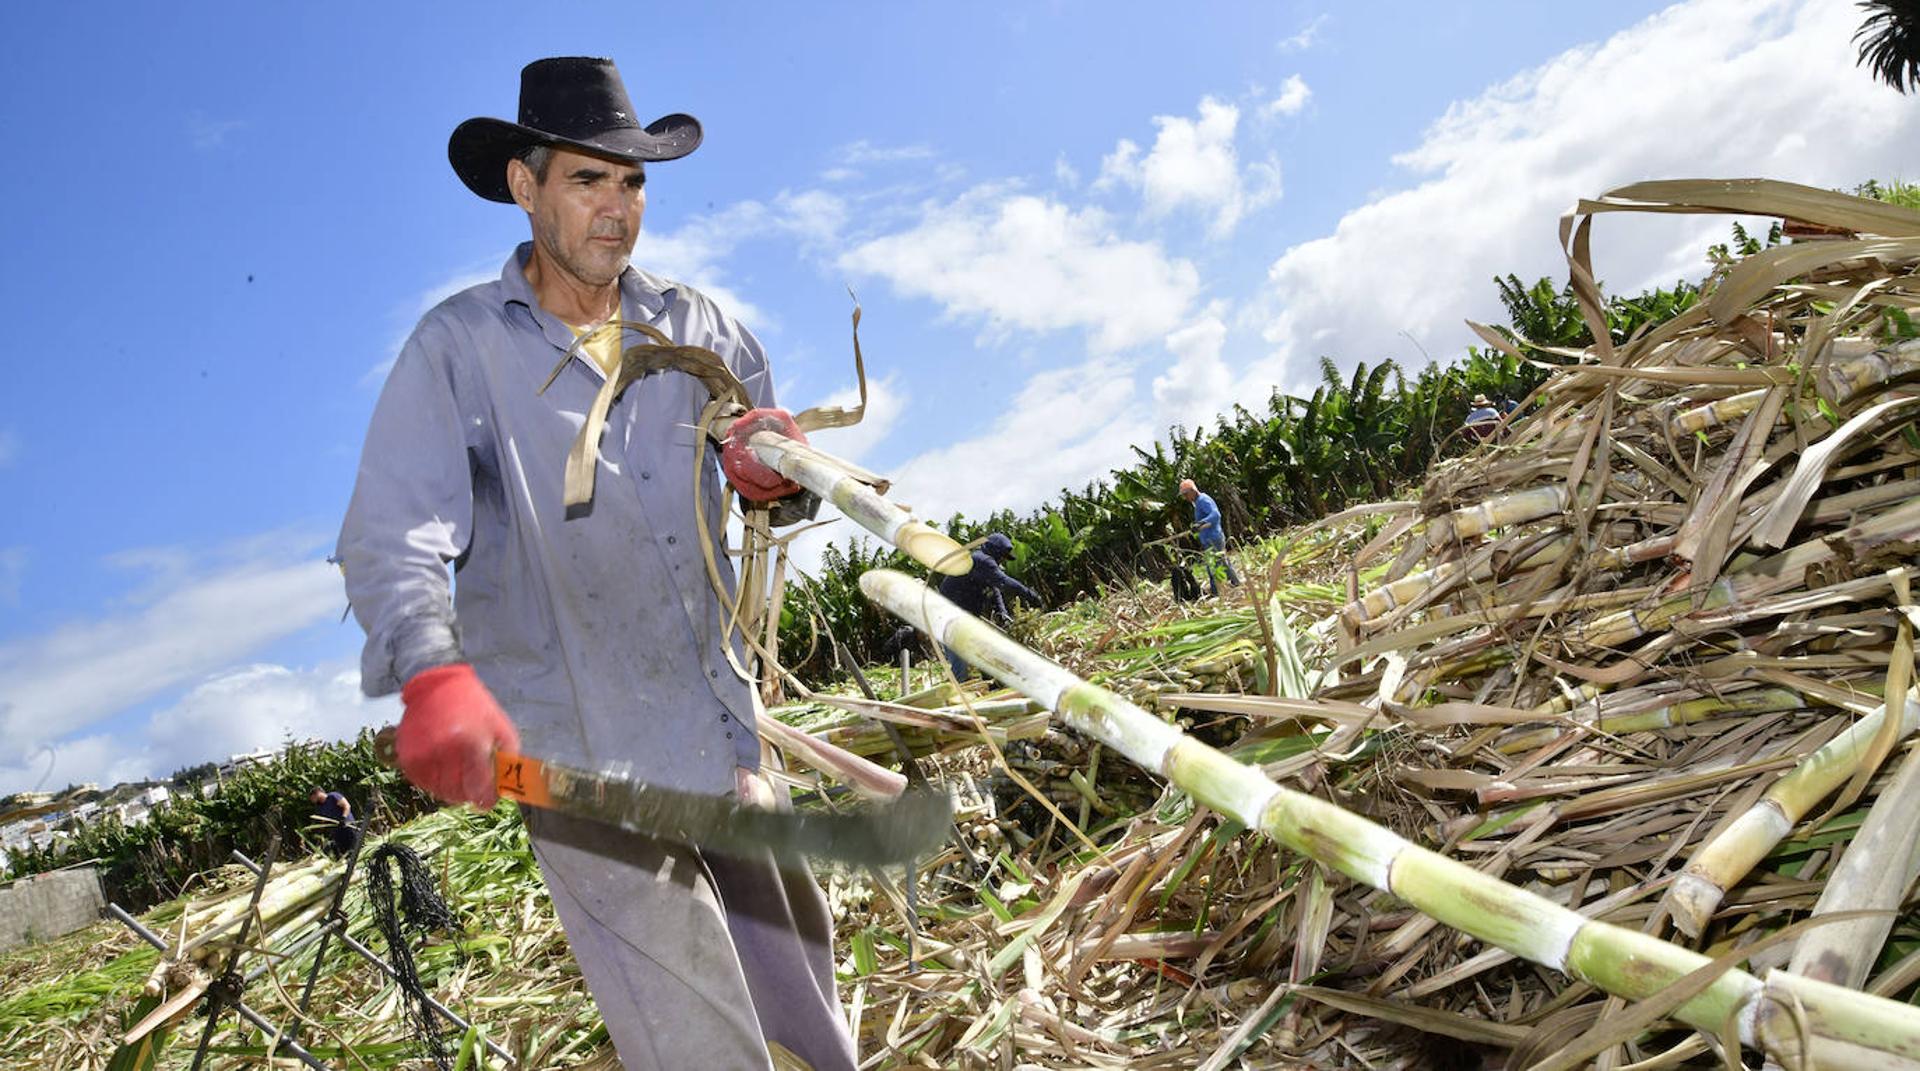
[{"xmin": 338, "ymin": 58, "xmax": 854, "ymax": 1071}]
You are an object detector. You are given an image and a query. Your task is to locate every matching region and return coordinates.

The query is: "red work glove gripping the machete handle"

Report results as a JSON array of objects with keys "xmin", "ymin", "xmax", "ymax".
[{"xmin": 394, "ymin": 662, "xmax": 520, "ymax": 810}]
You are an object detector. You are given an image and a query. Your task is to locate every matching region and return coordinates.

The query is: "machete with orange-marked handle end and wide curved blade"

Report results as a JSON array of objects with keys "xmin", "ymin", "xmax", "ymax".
[{"xmin": 374, "ymin": 726, "xmax": 952, "ymax": 866}]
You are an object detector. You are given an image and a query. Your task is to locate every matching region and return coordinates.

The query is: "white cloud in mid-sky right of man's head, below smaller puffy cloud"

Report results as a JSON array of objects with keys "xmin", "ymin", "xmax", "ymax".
[{"xmin": 837, "ymin": 186, "xmax": 1200, "ymax": 353}]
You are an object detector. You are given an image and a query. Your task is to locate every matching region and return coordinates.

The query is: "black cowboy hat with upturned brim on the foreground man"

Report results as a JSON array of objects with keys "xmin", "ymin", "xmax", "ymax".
[{"xmin": 447, "ymin": 56, "xmax": 701, "ymax": 203}]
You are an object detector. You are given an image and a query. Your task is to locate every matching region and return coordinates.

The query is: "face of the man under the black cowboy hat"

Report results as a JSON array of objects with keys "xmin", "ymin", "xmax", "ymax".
[{"xmin": 507, "ymin": 148, "xmax": 647, "ymax": 286}]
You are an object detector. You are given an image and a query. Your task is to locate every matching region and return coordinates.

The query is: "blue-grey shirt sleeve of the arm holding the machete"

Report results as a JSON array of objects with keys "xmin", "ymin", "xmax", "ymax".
[{"xmin": 338, "ymin": 317, "xmax": 472, "ymax": 695}]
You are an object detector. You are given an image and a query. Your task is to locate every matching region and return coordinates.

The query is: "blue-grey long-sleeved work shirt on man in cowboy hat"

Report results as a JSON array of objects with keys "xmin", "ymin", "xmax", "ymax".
[{"xmin": 338, "ymin": 244, "xmax": 774, "ymax": 793}]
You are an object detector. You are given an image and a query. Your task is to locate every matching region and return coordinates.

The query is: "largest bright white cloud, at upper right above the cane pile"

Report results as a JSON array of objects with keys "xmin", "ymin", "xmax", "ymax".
[{"xmin": 1242, "ymin": 0, "xmax": 1920, "ymax": 399}]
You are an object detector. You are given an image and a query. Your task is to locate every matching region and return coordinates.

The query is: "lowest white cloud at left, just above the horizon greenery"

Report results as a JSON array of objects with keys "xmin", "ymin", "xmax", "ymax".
[{"xmin": 0, "ymin": 662, "xmax": 399, "ymax": 793}]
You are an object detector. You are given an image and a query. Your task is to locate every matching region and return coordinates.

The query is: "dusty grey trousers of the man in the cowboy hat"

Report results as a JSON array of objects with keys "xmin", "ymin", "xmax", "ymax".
[{"xmin": 522, "ymin": 808, "xmax": 856, "ymax": 1071}]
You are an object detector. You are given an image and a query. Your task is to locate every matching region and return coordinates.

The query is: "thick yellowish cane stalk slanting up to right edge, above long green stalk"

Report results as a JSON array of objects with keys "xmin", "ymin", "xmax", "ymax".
[{"xmin": 1667, "ymin": 687, "xmax": 1920, "ymax": 937}]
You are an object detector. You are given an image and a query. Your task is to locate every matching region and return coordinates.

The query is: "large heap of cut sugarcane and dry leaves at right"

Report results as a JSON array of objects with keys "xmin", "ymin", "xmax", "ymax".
[{"xmin": 821, "ymin": 182, "xmax": 1920, "ymax": 1067}]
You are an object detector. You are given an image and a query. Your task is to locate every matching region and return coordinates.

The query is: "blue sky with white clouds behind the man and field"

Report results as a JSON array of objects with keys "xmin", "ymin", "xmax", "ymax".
[{"xmin": 0, "ymin": 0, "xmax": 1920, "ymax": 793}]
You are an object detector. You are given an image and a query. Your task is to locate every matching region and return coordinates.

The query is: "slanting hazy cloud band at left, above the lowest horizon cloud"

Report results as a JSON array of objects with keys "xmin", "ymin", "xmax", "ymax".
[{"xmin": 0, "ymin": 537, "xmax": 346, "ymax": 760}]
